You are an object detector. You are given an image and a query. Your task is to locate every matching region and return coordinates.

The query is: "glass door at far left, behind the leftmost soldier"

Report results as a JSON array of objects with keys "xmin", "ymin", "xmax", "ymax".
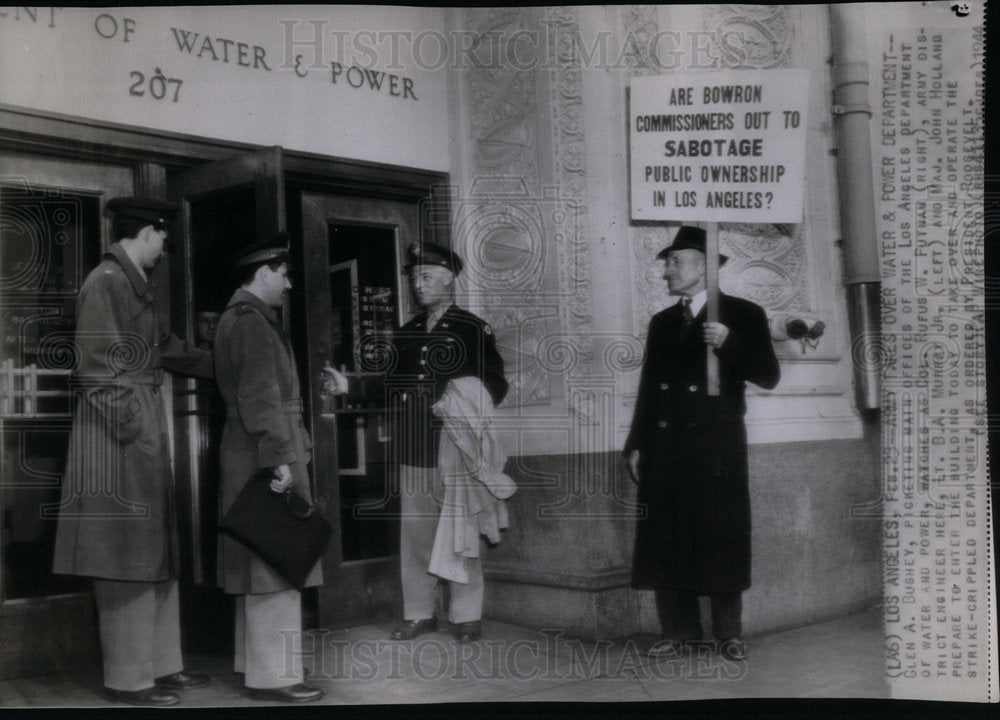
[{"xmin": 0, "ymin": 153, "xmax": 134, "ymax": 678}]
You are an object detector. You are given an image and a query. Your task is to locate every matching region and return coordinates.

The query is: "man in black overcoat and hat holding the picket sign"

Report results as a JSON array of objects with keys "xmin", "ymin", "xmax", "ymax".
[{"xmin": 623, "ymin": 226, "xmax": 780, "ymax": 660}]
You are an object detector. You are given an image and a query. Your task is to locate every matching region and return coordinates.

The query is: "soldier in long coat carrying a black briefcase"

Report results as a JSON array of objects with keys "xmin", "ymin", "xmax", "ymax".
[{"xmin": 214, "ymin": 234, "xmax": 323, "ymax": 702}]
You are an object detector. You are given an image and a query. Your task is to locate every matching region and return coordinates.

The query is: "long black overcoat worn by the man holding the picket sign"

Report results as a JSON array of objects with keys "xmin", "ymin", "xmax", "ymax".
[{"xmin": 624, "ymin": 295, "xmax": 780, "ymax": 595}]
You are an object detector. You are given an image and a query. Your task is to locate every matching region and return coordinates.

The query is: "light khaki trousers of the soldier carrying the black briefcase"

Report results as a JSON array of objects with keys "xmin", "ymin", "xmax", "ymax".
[{"xmin": 233, "ymin": 589, "xmax": 303, "ymax": 690}]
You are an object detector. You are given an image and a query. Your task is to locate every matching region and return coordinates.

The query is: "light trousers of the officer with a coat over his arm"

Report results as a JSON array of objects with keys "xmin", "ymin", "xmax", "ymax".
[{"xmin": 399, "ymin": 465, "xmax": 483, "ymax": 623}]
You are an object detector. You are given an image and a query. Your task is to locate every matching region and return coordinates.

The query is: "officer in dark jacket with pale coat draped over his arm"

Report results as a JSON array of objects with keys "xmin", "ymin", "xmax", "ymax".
[{"xmin": 326, "ymin": 242, "xmax": 508, "ymax": 641}]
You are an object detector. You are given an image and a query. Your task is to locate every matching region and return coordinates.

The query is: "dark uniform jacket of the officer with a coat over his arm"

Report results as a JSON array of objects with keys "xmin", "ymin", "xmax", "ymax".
[{"xmin": 366, "ymin": 304, "xmax": 508, "ymax": 467}]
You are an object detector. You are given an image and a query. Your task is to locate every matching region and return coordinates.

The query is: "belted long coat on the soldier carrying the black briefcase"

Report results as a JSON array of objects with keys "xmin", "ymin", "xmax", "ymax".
[{"xmin": 213, "ymin": 288, "xmax": 322, "ymax": 594}]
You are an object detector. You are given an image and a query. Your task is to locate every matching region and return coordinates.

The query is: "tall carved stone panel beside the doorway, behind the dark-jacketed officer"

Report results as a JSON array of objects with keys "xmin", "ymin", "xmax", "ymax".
[{"xmin": 453, "ymin": 8, "xmax": 551, "ymax": 405}]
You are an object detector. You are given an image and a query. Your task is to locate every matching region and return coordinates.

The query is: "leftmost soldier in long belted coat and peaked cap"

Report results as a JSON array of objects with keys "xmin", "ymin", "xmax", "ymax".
[{"xmin": 52, "ymin": 198, "xmax": 212, "ymax": 706}]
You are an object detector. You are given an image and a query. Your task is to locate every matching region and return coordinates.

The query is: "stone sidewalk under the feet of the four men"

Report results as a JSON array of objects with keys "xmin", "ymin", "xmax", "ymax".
[{"xmin": 0, "ymin": 609, "xmax": 889, "ymax": 709}]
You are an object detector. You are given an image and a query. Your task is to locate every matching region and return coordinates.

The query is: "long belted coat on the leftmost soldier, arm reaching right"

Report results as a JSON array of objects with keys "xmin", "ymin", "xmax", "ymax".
[{"xmin": 52, "ymin": 243, "xmax": 212, "ymax": 582}]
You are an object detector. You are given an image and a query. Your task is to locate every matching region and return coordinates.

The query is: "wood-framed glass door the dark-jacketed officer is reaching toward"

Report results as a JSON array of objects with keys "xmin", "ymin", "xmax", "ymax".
[{"xmin": 300, "ymin": 192, "xmax": 420, "ymax": 627}]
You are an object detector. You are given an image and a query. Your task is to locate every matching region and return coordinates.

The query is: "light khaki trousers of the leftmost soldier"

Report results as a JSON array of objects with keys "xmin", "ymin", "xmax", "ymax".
[{"xmin": 94, "ymin": 578, "xmax": 184, "ymax": 692}]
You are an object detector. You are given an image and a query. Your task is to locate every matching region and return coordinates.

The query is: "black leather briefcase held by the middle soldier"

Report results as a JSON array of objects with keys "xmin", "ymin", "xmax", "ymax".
[{"xmin": 219, "ymin": 471, "xmax": 333, "ymax": 590}]
